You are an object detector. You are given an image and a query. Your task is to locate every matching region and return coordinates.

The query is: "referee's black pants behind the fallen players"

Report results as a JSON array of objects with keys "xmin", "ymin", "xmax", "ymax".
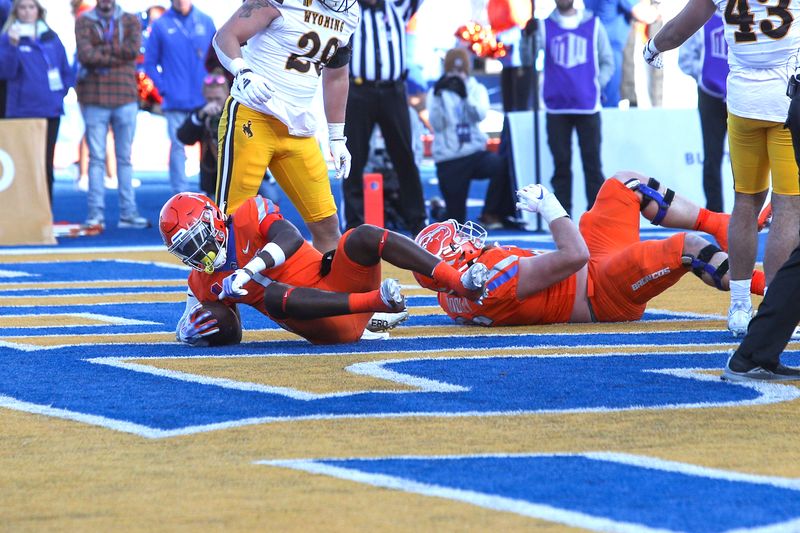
[{"xmin": 342, "ymin": 81, "xmax": 426, "ymax": 235}]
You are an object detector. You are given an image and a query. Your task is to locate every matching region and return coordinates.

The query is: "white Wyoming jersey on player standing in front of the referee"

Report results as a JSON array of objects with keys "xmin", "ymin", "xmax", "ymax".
[{"xmin": 231, "ymin": 0, "xmax": 361, "ymax": 137}]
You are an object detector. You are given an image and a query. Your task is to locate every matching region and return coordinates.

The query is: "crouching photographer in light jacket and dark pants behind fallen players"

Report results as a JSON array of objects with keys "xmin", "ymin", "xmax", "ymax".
[{"xmin": 426, "ymin": 48, "xmax": 516, "ymax": 229}]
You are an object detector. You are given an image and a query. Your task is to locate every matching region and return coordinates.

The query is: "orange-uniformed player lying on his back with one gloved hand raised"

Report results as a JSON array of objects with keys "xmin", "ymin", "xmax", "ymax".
[{"xmin": 416, "ymin": 172, "xmax": 764, "ymax": 326}]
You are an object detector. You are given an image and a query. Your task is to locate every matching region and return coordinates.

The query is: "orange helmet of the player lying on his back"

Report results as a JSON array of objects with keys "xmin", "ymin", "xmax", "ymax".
[{"xmin": 414, "ymin": 218, "xmax": 488, "ymax": 292}]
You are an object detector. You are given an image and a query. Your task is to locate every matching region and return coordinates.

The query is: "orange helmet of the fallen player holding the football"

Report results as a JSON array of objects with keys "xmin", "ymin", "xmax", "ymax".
[{"xmin": 158, "ymin": 192, "xmax": 228, "ymax": 274}]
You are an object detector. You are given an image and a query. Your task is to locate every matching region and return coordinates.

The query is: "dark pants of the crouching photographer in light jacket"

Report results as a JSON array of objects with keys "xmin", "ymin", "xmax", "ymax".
[{"xmin": 436, "ymin": 150, "xmax": 515, "ymax": 223}]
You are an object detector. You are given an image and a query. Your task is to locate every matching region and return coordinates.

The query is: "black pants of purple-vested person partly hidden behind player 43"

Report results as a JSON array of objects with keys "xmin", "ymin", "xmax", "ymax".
[{"xmin": 697, "ymin": 87, "xmax": 728, "ymax": 213}]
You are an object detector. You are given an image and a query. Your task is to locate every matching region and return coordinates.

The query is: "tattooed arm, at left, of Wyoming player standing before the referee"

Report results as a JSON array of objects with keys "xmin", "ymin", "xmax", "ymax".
[{"xmin": 214, "ymin": 0, "xmax": 281, "ymax": 69}]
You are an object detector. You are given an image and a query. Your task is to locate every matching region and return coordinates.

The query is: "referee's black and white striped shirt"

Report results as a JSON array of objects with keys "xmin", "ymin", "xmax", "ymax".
[{"xmin": 350, "ymin": 0, "xmax": 424, "ymax": 81}]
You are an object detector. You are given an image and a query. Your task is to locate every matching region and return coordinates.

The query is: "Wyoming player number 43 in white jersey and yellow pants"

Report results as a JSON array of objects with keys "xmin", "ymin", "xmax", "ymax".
[{"xmin": 644, "ymin": 0, "xmax": 800, "ymax": 337}]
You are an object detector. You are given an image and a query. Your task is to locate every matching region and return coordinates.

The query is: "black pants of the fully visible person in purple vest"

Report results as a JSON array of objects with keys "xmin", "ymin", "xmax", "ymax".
[{"xmin": 547, "ymin": 112, "xmax": 605, "ymax": 214}]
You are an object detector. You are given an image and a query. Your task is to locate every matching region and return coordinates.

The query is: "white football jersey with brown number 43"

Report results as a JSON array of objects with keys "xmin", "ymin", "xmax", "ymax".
[{"xmin": 714, "ymin": 0, "xmax": 800, "ymax": 68}]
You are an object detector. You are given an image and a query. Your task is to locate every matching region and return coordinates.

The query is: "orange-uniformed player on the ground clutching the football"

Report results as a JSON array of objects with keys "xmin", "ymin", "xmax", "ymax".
[{"xmin": 159, "ymin": 193, "xmax": 488, "ymax": 344}]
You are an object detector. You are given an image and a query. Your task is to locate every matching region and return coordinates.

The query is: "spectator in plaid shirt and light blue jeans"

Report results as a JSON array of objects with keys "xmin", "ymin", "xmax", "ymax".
[{"xmin": 75, "ymin": 0, "xmax": 150, "ymax": 228}]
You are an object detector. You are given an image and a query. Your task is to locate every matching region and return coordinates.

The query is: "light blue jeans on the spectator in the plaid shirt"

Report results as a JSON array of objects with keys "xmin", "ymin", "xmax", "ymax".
[{"xmin": 81, "ymin": 102, "xmax": 139, "ymax": 219}]
